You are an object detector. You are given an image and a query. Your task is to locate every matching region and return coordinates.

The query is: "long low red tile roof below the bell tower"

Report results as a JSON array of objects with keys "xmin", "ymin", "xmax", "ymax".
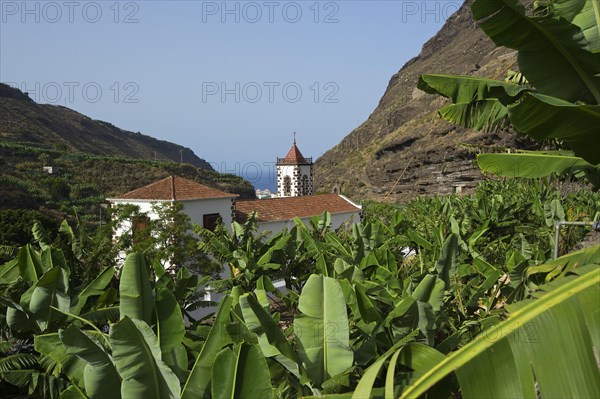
[{"xmin": 235, "ymin": 194, "xmax": 361, "ymax": 222}]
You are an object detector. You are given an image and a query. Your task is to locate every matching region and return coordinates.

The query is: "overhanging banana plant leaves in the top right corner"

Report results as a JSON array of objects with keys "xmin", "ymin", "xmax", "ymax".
[{"xmin": 417, "ymin": 0, "xmax": 600, "ymax": 182}]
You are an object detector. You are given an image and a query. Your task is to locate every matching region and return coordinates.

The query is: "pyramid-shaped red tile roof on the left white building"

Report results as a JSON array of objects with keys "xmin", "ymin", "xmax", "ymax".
[{"xmin": 114, "ymin": 176, "xmax": 237, "ymax": 201}]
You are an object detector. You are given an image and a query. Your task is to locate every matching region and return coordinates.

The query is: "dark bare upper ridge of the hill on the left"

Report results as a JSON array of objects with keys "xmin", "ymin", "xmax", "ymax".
[{"xmin": 0, "ymin": 83, "xmax": 212, "ymax": 170}]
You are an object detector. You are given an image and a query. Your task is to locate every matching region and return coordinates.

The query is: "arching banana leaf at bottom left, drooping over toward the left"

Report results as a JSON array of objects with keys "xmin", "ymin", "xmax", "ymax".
[{"xmin": 59, "ymin": 325, "xmax": 121, "ymax": 399}]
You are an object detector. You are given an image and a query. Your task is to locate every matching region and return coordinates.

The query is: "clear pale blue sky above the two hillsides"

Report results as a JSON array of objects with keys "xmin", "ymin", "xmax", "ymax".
[{"xmin": 0, "ymin": 0, "xmax": 462, "ymax": 181}]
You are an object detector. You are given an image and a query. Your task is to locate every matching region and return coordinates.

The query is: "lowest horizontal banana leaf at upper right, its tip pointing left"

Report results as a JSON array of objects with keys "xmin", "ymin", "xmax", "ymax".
[{"xmin": 477, "ymin": 152, "xmax": 600, "ymax": 189}]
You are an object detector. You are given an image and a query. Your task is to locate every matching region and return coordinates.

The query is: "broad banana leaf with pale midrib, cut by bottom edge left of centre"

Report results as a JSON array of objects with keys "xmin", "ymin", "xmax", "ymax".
[{"xmin": 211, "ymin": 343, "xmax": 273, "ymax": 399}]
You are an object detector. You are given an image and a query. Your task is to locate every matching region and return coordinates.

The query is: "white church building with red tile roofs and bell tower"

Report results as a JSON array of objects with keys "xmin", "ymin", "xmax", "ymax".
[{"xmin": 108, "ymin": 133, "xmax": 362, "ymax": 245}]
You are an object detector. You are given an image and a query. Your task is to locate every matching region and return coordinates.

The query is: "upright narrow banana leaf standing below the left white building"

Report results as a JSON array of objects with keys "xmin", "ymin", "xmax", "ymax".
[{"xmin": 119, "ymin": 253, "xmax": 154, "ymax": 324}]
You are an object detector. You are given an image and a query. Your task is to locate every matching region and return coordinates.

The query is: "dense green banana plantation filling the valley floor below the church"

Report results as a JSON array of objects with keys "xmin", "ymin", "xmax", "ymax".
[{"xmin": 0, "ymin": 180, "xmax": 600, "ymax": 398}]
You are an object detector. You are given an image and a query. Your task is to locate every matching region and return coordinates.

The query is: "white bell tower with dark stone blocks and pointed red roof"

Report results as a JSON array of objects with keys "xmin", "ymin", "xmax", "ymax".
[{"xmin": 277, "ymin": 132, "xmax": 313, "ymax": 197}]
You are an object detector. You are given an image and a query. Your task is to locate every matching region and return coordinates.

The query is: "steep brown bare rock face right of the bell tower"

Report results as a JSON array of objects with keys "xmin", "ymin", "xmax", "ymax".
[{"xmin": 315, "ymin": 0, "xmax": 531, "ymax": 201}]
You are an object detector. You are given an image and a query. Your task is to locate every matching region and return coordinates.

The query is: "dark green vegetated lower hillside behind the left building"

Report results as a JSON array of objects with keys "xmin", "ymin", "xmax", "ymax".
[{"xmin": 0, "ymin": 140, "xmax": 254, "ymax": 245}]
